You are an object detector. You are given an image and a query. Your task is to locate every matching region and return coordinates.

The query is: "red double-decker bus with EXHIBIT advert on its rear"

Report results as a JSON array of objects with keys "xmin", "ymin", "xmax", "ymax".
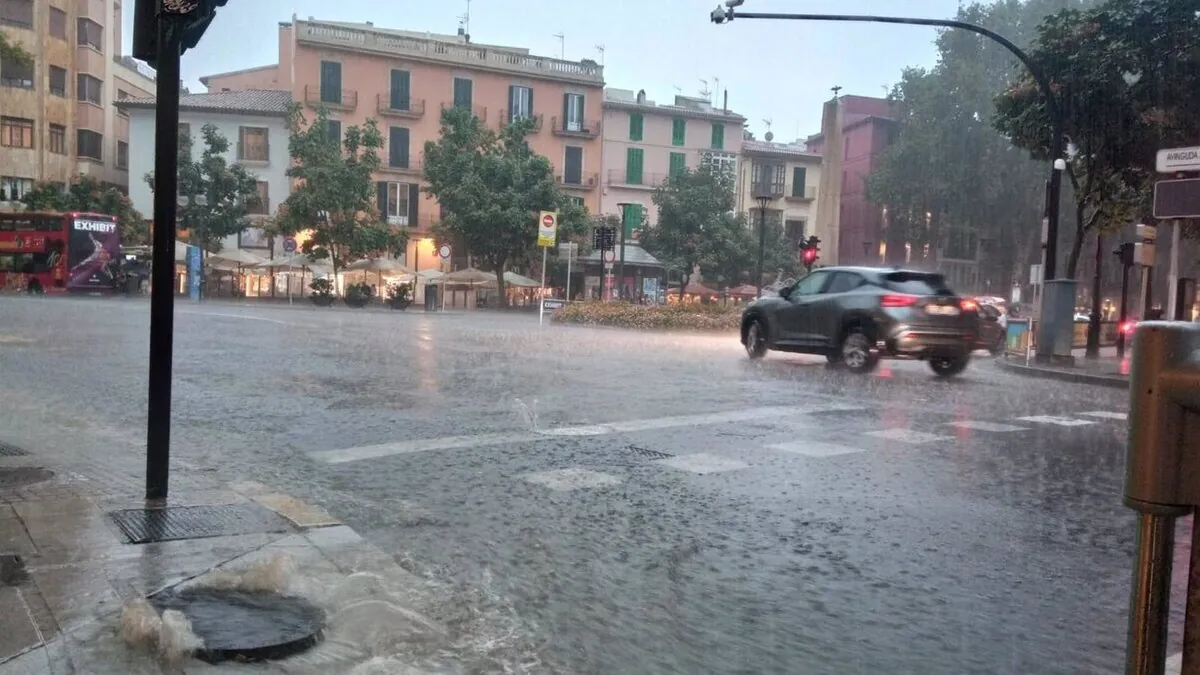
[{"xmin": 0, "ymin": 211, "xmax": 121, "ymax": 293}]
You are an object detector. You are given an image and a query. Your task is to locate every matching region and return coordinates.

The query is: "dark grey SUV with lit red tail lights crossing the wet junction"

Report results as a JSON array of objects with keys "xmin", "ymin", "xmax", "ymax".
[{"xmin": 742, "ymin": 267, "xmax": 979, "ymax": 377}]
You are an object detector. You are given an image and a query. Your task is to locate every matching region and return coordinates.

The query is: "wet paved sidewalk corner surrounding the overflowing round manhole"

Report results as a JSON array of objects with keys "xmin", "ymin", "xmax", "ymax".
[{"xmin": 0, "ymin": 461, "xmax": 458, "ymax": 675}]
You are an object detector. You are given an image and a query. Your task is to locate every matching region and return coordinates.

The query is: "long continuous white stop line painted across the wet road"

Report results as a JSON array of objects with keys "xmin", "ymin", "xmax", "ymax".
[{"xmin": 308, "ymin": 404, "xmax": 864, "ymax": 464}]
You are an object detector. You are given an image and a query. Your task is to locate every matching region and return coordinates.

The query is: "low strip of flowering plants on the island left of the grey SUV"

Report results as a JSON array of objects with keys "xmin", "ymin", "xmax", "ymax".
[{"xmin": 553, "ymin": 301, "xmax": 742, "ymax": 331}]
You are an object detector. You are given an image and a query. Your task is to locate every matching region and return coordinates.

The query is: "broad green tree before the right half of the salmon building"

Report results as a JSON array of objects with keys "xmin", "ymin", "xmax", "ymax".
[{"xmin": 425, "ymin": 108, "xmax": 589, "ymax": 301}]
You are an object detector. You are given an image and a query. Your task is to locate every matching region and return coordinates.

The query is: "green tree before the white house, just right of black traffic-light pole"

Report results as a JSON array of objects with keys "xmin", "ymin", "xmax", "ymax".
[{"xmin": 145, "ymin": 124, "xmax": 258, "ymax": 252}]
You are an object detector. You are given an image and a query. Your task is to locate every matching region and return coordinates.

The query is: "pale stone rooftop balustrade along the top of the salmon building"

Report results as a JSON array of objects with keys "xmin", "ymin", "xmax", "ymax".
[{"xmin": 295, "ymin": 20, "xmax": 604, "ymax": 86}]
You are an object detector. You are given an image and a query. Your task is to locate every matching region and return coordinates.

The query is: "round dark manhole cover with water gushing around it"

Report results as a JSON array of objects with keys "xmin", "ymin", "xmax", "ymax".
[{"xmin": 149, "ymin": 589, "xmax": 325, "ymax": 663}]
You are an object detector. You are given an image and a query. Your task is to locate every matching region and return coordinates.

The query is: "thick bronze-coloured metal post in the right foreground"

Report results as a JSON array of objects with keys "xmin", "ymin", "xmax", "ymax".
[{"xmin": 1124, "ymin": 321, "xmax": 1200, "ymax": 675}]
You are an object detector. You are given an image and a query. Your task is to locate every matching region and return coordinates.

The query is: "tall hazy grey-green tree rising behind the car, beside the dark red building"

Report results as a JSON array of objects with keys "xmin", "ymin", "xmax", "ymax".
[{"xmin": 866, "ymin": 0, "xmax": 1079, "ymax": 286}]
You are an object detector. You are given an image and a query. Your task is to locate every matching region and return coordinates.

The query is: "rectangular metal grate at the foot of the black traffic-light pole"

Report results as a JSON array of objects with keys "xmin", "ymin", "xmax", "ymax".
[{"xmin": 109, "ymin": 504, "xmax": 293, "ymax": 544}]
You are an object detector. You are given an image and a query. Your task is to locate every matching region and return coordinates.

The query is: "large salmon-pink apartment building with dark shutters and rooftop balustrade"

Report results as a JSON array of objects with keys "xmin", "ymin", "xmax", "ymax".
[{"xmin": 200, "ymin": 17, "xmax": 604, "ymax": 269}]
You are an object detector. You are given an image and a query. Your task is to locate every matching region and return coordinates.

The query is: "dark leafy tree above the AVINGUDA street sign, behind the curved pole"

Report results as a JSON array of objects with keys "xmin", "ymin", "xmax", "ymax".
[{"xmin": 995, "ymin": 0, "xmax": 1200, "ymax": 270}]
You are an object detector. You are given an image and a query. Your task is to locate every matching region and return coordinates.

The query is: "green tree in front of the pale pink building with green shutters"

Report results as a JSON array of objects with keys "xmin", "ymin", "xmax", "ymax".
[{"xmin": 642, "ymin": 168, "xmax": 757, "ymax": 295}]
